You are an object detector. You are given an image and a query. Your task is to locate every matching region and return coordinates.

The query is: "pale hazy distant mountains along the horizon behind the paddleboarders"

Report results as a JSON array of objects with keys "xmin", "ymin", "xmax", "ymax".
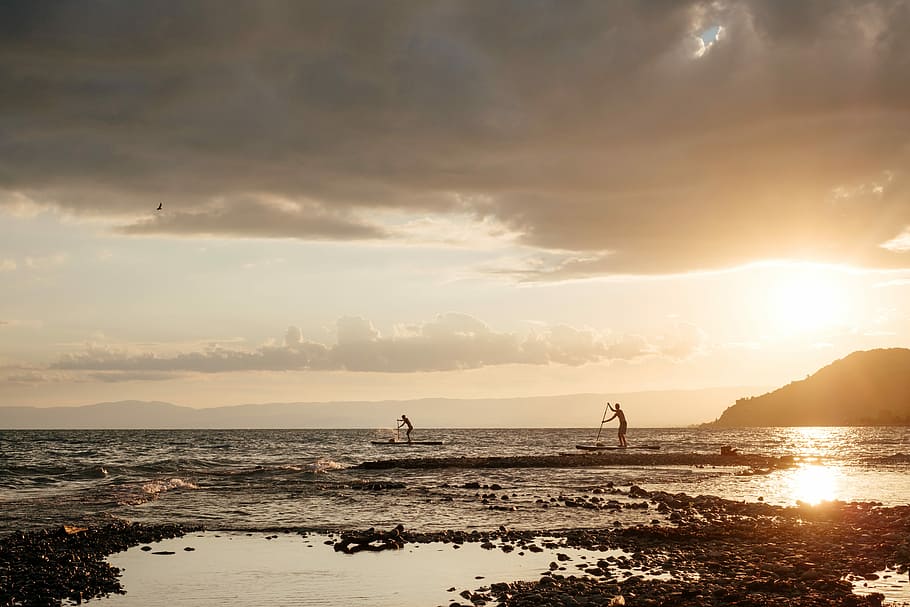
[{"xmin": 0, "ymin": 387, "xmax": 761, "ymax": 429}]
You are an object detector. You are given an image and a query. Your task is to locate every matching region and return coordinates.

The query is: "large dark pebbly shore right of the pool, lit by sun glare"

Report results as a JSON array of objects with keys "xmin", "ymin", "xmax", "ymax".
[{"xmin": 336, "ymin": 494, "xmax": 910, "ymax": 607}]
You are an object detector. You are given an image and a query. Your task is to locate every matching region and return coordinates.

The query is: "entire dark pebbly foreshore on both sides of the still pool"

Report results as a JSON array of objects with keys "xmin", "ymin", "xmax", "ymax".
[{"xmin": 0, "ymin": 486, "xmax": 910, "ymax": 607}]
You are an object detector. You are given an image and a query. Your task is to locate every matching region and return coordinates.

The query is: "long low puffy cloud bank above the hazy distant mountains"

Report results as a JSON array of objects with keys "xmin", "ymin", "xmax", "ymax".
[{"xmin": 51, "ymin": 313, "xmax": 701, "ymax": 381}]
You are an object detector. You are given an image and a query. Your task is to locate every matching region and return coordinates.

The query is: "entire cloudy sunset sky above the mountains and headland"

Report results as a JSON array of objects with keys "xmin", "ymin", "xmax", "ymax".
[{"xmin": 0, "ymin": 0, "xmax": 910, "ymax": 407}]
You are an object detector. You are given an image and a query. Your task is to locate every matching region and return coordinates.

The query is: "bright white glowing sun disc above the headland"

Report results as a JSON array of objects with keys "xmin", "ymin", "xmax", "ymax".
[{"xmin": 769, "ymin": 270, "xmax": 849, "ymax": 334}]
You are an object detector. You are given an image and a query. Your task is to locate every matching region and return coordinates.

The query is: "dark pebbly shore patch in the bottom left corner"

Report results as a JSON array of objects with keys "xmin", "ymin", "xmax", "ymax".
[{"xmin": 0, "ymin": 522, "xmax": 195, "ymax": 607}]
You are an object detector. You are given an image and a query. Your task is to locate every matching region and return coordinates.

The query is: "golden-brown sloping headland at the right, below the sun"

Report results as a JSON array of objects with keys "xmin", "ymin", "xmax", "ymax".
[{"xmin": 709, "ymin": 348, "xmax": 910, "ymax": 428}]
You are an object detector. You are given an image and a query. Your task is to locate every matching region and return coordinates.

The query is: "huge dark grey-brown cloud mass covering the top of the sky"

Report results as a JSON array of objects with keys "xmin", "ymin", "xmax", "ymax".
[{"xmin": 0, "ymin": 0, "xmax": 910, "ymax": 278}]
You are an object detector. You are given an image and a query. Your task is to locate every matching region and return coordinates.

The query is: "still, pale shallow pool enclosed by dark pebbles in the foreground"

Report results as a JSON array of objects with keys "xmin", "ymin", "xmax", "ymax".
[{"xmin": 100, "ymin": 532, "xmax": 625, "ymax": 607}]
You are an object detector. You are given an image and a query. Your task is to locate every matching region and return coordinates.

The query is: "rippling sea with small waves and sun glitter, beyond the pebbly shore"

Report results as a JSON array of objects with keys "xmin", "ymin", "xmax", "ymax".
[{"xmin": 0, "ymin": 427, "xmax": 910, "ymax": 533}]
